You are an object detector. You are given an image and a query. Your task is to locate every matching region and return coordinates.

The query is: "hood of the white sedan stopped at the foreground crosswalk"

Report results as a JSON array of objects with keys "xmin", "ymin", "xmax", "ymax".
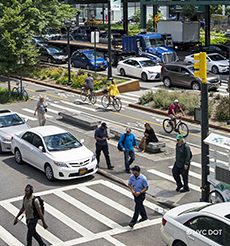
[{"xmin": 49, "ymin": 145, "xmax": 93, "ymax": 162}]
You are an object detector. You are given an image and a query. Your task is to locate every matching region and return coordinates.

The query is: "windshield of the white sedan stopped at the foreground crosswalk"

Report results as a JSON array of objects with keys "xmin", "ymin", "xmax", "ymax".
[{"xmin": 44, "ymin": 132, "xmax": 82, "ymax": 151}]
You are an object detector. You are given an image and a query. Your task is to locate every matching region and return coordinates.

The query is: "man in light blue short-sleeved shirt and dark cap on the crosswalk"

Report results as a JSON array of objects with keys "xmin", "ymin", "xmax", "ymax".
[{"xmin": 128, "ymin": 166, "xmax": 149, "ymax": 227}]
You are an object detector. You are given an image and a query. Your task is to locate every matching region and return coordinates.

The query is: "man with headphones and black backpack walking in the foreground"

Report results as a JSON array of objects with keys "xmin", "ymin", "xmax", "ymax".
[{"xmin": 14, "ymin": 184, "xmax": 48, "ymax": 246}]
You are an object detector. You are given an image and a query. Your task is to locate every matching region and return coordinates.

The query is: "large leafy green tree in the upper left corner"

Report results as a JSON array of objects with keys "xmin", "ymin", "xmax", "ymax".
[{"xmin": 0, "ymin": 0, "xmax": 78, "ymax": 96}]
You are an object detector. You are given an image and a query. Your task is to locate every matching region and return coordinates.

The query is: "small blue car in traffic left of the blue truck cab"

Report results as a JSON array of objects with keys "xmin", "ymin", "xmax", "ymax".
[{"xmin": 71, "ymin": 50, "xmax": 108, "ymax": 70}]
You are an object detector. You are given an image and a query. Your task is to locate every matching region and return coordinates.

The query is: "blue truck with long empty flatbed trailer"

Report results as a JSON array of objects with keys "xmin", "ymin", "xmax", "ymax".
[{"xmin": 48, "ymin": 33, "xmax": 178, "ymax": 65}]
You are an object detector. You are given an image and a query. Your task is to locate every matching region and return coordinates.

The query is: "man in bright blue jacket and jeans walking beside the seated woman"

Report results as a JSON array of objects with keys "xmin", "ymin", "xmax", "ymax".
[{"xmin": 119, "ymin": 127, "xmax": 139, "ymax": 173}]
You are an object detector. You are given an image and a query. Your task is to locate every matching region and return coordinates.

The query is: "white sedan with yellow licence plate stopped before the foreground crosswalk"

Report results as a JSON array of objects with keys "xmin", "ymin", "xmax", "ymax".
[{"xmin": 11, "ymin": 126, "xmax": 98, "ymax": 181}]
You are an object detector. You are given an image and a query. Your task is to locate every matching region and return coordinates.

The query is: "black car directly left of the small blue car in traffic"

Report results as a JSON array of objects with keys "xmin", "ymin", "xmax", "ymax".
[{"xmin": 38, "ymin": 45, "xmax": 68, "ymax": 63}]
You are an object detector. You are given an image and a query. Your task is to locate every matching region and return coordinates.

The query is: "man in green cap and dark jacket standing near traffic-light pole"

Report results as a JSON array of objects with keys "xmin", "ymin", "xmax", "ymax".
[{"xmin": 172, "ymin": 134, "xmax": 190, "ymax": 192}]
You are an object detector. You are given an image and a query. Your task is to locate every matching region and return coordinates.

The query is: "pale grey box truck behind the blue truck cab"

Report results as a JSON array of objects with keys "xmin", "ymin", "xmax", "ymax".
[{"xmin": 157, "ymin": 20, "xmax": 200, "ymax": 50}]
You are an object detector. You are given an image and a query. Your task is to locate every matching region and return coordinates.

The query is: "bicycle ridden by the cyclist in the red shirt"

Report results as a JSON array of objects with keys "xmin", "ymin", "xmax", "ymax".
[{"xmin": 163, "ymin": 116, "xmax": 189, "ymax": 138}]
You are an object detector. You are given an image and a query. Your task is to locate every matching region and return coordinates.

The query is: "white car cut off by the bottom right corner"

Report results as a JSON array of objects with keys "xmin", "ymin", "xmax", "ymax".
[{"xmin": 160, "ymin": 202, "xmax": 230, "ymax": 246}]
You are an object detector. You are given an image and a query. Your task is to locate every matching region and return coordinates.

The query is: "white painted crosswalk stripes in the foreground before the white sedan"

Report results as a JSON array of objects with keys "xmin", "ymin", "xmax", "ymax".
[{"xmin": 0, "ymin": 180, "xmax": 165, "ymax": 246}]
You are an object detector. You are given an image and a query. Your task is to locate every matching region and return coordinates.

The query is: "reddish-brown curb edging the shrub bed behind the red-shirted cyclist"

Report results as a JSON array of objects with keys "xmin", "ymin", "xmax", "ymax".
[{"xmin": 129, "ymin": 103, "xmax": 230, "ymax": 132}]
